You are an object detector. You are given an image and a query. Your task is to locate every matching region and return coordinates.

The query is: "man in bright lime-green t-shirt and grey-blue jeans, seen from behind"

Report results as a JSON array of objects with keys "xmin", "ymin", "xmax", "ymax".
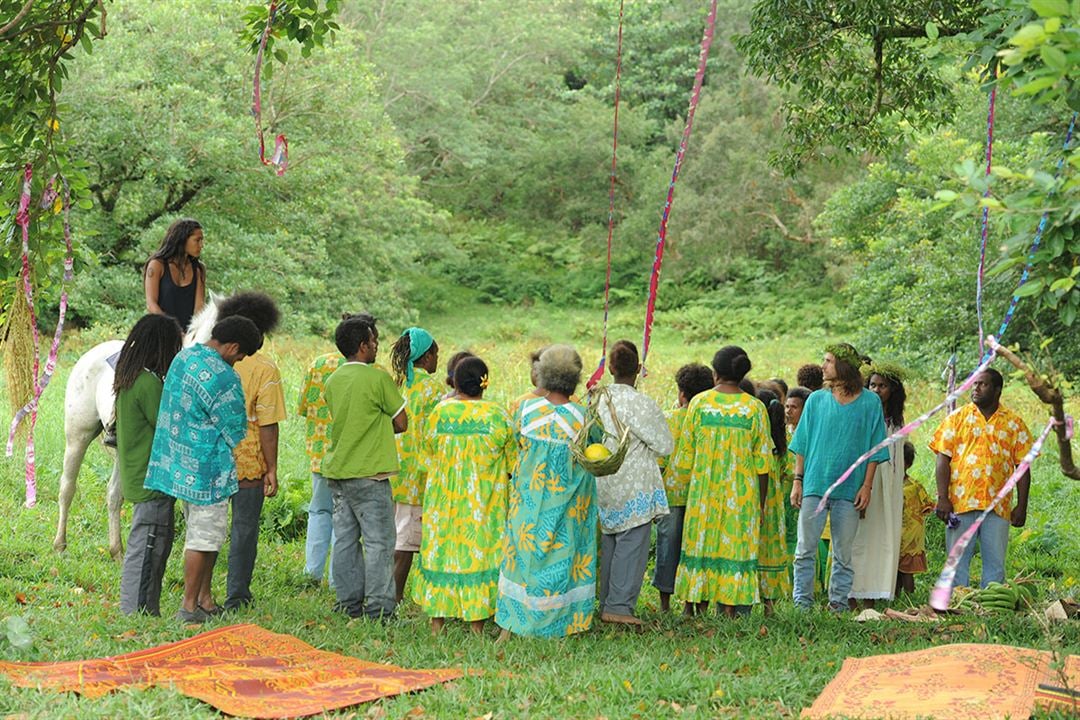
[{"xmin": 323, "ymin": 315, "xmax": 408, "ymax": 617}]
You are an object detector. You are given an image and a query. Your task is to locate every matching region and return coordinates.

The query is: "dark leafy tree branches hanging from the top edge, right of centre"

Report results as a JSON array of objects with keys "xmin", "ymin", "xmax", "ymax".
[{"xmin": 739, "ymin": 0, "xmax": 983, "ymax": 168}]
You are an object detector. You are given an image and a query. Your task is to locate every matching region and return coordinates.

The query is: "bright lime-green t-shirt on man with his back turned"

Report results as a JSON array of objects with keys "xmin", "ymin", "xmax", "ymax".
[{"xmin": 322, "ymin": 363, "xmax": 405, "ymax": 480}]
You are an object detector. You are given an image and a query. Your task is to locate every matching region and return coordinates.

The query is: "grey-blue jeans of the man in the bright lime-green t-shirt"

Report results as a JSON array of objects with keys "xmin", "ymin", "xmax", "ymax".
[{"xmin": 327, "ymin": 477, "xmax": 397, "ymax": 617}]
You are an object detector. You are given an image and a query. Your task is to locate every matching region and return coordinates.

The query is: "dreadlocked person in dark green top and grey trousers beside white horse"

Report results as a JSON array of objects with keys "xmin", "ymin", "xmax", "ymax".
[{"xmin": 112, "ymin": 315, "xmax": 183, "ymax": 615}]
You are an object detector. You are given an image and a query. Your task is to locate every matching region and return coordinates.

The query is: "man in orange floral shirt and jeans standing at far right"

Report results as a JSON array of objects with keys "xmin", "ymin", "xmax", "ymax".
[{"xmin": 930, "ymin": 369, "xmax": 1031, "ymax": 587}]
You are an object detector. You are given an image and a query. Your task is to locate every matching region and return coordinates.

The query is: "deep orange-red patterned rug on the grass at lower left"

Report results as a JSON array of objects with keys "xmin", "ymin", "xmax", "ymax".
[{"xmin": 0, "ymin": 625, "xmax": 461, "ymax": 718}]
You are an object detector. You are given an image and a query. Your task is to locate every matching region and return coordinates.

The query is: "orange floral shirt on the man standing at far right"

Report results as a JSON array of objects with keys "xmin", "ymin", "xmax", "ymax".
[{"xmin": 930, "ymin": 403, "xmax": 1031, "ymax": 520}]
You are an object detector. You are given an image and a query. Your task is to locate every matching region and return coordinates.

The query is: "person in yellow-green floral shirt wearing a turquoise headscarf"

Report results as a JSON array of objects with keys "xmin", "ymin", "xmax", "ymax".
[{"xmin": 390, "ymin": 327, "xmax": 443, "ymax": 602}]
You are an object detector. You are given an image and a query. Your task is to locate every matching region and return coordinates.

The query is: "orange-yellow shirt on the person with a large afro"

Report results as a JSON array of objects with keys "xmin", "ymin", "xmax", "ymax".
[{"xmin": 232, "ymin": 353, "xmax": 285, "ymax": 481}]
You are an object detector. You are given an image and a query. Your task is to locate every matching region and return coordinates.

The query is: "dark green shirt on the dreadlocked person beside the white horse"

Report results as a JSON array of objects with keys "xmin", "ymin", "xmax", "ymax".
[{"xmin": 117, "ymin": 370, "xmax": 162, "ymax": 503}]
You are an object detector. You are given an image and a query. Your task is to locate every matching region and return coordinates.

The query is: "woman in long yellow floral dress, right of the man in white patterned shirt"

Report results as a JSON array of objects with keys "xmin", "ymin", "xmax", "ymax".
[{"xmin": 674, "ymin": 345, "xmax": 771, "ymax": 616}]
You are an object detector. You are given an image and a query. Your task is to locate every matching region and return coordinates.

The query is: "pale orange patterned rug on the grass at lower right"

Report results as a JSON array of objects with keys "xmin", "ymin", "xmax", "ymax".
[{"xmin": 802, "ymin": 644, "xmax": 1080, "ymax": 720}]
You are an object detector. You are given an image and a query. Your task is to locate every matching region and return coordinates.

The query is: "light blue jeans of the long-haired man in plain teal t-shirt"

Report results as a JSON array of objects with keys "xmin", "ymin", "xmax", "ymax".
[{"xmin": 795, "ymin": 495, "xmax": 859, "ymax": 608}]
